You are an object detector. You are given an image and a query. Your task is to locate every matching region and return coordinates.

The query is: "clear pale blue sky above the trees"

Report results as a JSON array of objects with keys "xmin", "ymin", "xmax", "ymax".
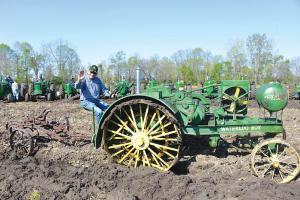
[{"xmin": 0, "ymin": 0, "xmax": 300, "ymax": 65}]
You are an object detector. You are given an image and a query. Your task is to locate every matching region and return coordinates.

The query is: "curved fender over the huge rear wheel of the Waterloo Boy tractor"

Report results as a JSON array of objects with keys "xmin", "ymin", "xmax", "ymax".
[{"xmin": 92, "ymin": 94, "xmax": 178, "ymax": 149}]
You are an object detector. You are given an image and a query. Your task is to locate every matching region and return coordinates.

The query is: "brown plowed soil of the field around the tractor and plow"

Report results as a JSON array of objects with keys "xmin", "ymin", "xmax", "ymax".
[{"xmin": 0, "ymin": 101, "xmax": 300, "ymax": 200}]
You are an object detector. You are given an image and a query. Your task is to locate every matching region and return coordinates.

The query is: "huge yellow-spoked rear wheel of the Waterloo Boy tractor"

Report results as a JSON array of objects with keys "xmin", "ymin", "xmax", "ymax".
[{"xmin": 103, "ymin": 100, "xmax": 181, "ymax": 171}]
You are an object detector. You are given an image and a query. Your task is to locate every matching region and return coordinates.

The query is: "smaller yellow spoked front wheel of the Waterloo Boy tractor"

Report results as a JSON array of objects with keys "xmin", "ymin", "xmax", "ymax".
[{"xmin": 251, "ymin": 139, "xmax": 300, "ymax": 183}]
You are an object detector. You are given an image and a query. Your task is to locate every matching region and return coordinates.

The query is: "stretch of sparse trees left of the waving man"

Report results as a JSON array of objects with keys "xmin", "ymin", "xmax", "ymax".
[{"xmin": 0, "ymin": 40, "xmax": 81, "ymax": 83}]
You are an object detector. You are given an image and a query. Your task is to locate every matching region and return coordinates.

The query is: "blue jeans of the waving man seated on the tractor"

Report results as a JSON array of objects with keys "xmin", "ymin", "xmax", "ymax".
[{"xmin": 80, "ymin": 99, "xmax": 109, "ymax": 124}]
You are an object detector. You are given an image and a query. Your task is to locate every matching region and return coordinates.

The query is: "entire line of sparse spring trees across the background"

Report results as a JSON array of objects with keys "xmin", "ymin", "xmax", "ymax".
[{"xmin": 0, "ymin": 33, "xmax": 300, "ymax": 85}]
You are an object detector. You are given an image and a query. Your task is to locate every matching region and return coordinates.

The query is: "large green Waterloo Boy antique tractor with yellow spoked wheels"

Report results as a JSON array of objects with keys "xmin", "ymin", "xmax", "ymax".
[{"xmin": 93, "ymin": 80, "xmax": 300, "ymax": 183}]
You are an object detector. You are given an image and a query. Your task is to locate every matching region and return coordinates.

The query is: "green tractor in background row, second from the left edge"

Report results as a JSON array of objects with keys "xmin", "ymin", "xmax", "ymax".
[{"xmin": 25, "ymin": 81, "xmax": 55, "ymax": 102}]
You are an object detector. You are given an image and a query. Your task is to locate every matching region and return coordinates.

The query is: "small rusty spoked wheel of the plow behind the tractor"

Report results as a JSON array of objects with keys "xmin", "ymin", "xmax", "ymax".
[{"xmin": 9, "ymin": 129, "xmax": 33, "ymax": 158}]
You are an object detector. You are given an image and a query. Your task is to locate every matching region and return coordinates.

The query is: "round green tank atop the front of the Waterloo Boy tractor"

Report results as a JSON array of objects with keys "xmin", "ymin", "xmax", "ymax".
[{"xmin": 256, "ymin": 82, "xmax": 288, "ymax": 112}]
